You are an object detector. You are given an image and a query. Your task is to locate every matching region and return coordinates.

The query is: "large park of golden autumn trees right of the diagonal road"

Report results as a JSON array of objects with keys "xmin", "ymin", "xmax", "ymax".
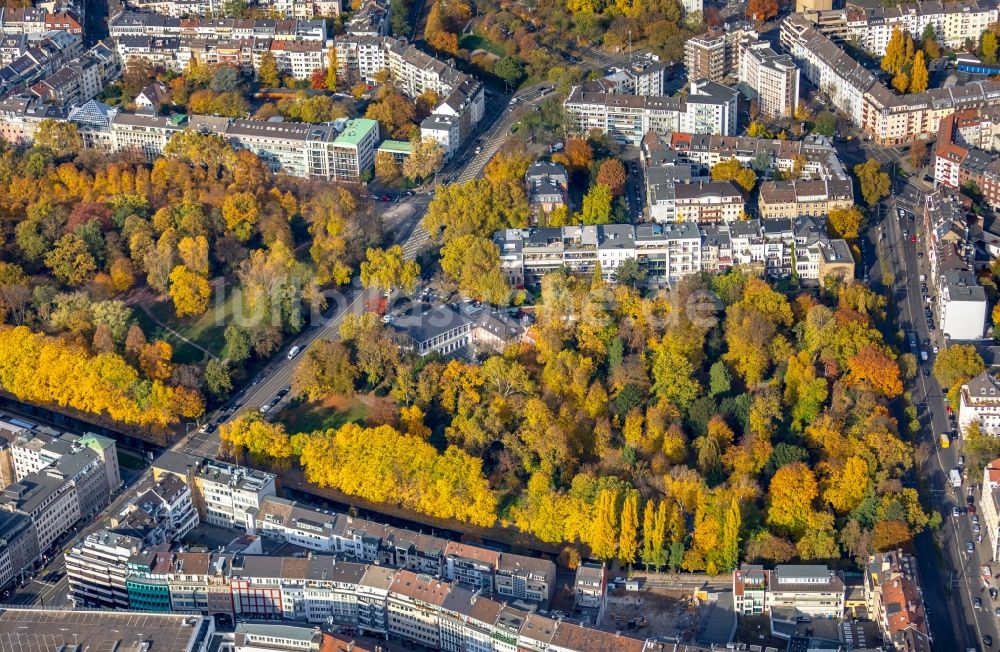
[{"xmin": 209, "ymin": 135, "xmax": 936, "ymax": 573}]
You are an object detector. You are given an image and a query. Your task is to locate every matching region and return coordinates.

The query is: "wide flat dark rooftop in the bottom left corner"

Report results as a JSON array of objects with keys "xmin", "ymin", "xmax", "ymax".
[{"xmin": 0, "ymin": 609, "xmax": 208, "ymax": 652}]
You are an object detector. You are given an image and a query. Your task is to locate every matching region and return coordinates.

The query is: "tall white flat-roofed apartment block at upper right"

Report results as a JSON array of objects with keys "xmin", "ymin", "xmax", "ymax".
[{"xmin": 737, "ymin": 39, "xmax": 799, "ymax": 118}]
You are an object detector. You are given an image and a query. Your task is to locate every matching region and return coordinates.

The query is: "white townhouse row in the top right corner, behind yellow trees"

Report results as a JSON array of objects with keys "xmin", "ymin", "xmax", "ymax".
[{"xmin": 807, "ymin": 0, "xmax": 1000, "ymax": 56}]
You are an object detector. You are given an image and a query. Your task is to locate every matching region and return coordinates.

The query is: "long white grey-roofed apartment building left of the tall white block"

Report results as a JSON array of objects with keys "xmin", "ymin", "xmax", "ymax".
[{"xmin": 563, "ymin": 79, "xmax": 739, "ymax": 145}]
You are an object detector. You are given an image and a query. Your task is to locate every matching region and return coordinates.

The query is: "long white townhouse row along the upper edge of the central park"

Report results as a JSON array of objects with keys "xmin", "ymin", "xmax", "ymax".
[{"xmin": 493, "ymin": 216, "xmax": 854, "ymax": 287}]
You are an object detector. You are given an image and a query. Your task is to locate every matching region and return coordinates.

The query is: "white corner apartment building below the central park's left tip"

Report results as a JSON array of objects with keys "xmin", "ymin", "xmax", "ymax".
[{"xmin": 194, "ymin": 461, "xmax": 275, "ymax": 529}]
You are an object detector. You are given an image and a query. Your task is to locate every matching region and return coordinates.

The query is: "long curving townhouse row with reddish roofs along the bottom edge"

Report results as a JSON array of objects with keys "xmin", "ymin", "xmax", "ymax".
[{"xmin": 70, "ymin": 545, "xmax": 645, "ymax": 652}]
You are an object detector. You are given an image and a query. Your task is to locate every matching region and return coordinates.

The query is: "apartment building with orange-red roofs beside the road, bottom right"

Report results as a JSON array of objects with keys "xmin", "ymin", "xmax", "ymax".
[{"xmin": 864, "ymin": 550, "xmax": 932, "ymax": 652}]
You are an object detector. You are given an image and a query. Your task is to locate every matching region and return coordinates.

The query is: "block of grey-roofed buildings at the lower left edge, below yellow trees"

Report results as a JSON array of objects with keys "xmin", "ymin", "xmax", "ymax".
[{"xmin": 0, "ymin": 418, "xmax": 122, "ymax": 587}]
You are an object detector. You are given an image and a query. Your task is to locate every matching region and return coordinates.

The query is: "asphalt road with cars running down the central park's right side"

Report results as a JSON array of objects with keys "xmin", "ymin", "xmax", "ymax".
[{"xmin": 870, "ymin": 178, "xmax": 1000, "ymax": 650}]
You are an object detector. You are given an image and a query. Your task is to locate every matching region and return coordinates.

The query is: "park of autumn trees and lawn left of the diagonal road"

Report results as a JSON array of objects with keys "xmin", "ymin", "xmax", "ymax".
[{"xmin": 0, "ymin": 126, "xmax": 382, "ymax": 442}]
